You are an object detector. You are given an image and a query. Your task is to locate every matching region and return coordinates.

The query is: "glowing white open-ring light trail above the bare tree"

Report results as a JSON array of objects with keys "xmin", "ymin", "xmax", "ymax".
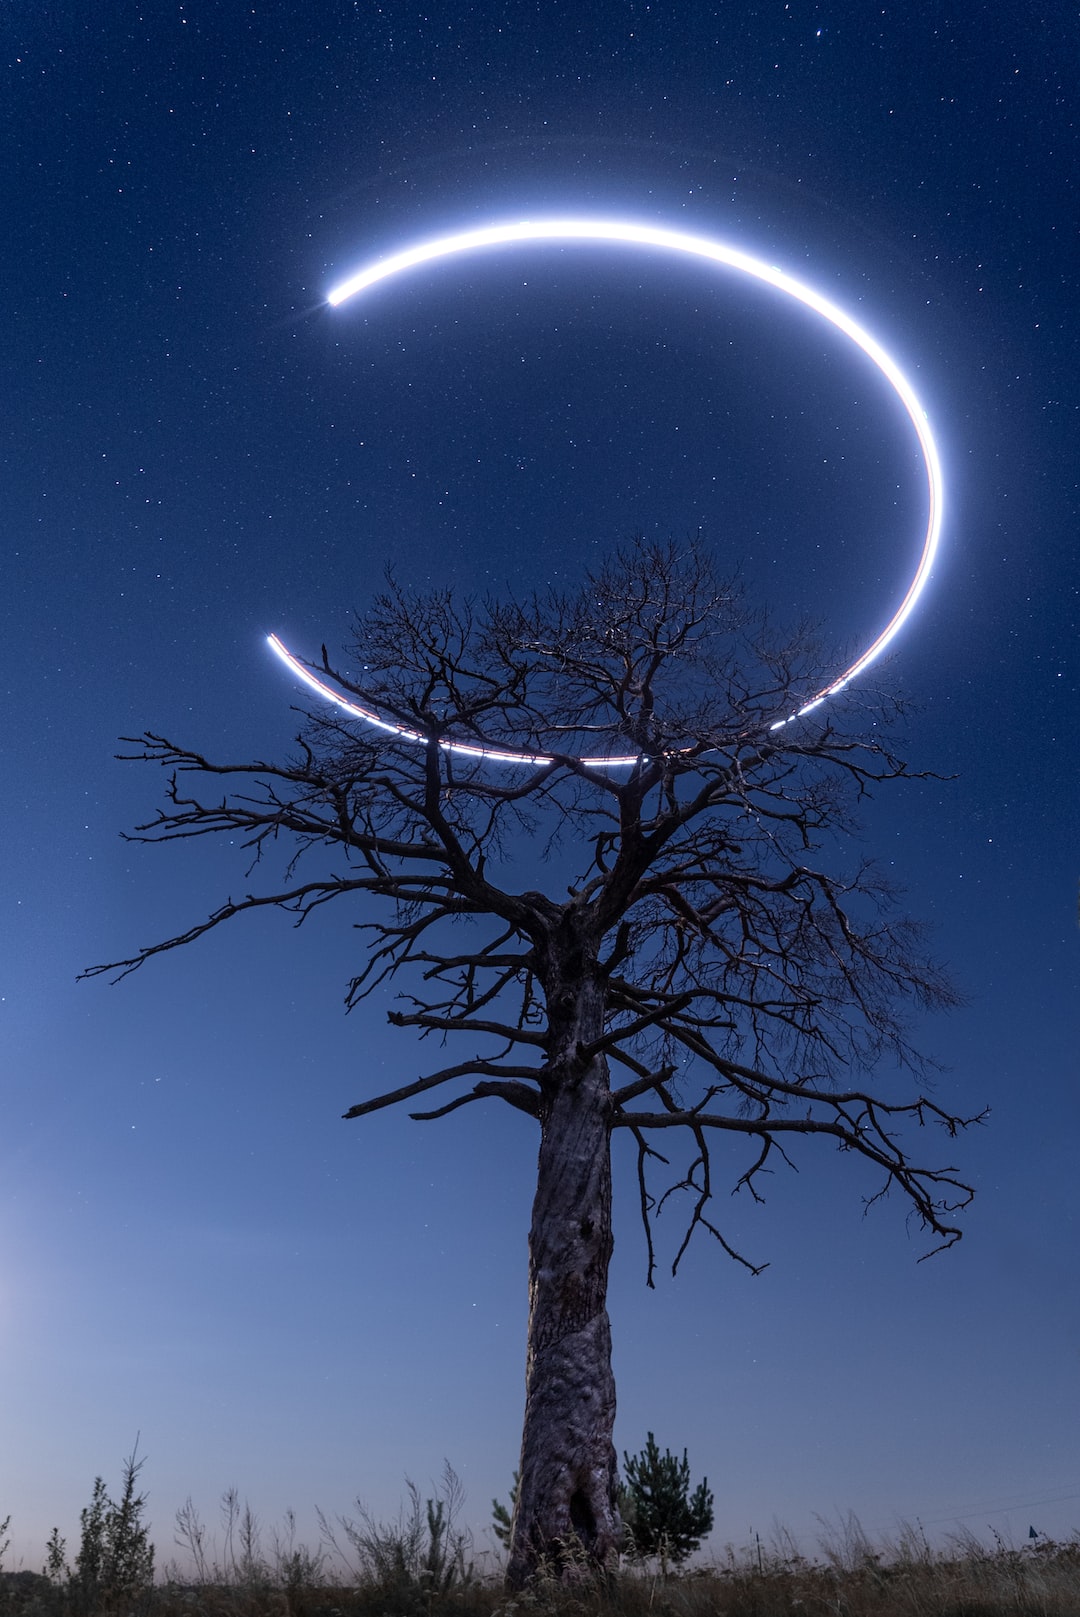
[{"xmin": 268, "ymin": 218, "xmax": 944, "ymax": 768}]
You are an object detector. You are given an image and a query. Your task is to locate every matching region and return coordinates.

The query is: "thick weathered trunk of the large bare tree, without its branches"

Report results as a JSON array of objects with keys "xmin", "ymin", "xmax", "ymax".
[{"xmin": 506, "ymin": 980, "xmax": 621, "ymax": 1588}]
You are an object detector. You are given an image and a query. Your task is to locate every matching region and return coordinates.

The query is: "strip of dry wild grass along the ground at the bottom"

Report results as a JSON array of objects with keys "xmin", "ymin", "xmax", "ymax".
[{"xmin": 0, "ymin": 1470, "xmax": 1080, "ymax": 1617}]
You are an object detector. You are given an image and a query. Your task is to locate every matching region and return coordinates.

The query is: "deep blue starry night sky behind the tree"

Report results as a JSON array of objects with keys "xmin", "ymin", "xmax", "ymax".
[{"xmin": 0, "ymin": 0, "xmax": 1080, "ymax": 1567}]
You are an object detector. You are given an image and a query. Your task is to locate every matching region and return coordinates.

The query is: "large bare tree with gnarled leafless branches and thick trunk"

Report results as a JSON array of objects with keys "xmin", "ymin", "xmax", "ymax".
[{"xmin": 87, "ymin": 543, "xmax": 972, "ymax": 1586}]
